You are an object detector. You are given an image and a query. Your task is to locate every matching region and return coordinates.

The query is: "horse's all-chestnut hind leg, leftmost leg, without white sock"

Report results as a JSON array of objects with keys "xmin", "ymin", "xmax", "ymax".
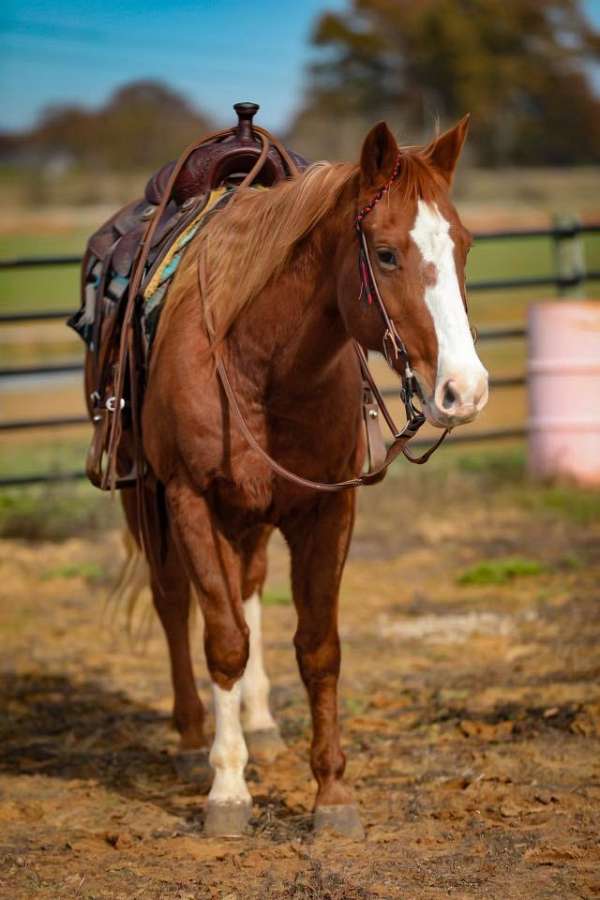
[{"xmin": 121, "ymin": 491, "xmax": 207, "ymax": 756}]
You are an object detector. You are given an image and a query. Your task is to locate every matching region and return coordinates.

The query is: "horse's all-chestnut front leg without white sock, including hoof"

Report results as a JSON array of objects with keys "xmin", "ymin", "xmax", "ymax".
[{"xmin": 283, "ymin": 493, "xmax": 363, "ymax": 837}]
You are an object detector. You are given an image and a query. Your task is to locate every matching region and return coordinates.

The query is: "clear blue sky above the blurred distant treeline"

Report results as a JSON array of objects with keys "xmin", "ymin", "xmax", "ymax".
[{"xmin": 0, "ymin": 0, "xmax": 600, "ymax": 130}]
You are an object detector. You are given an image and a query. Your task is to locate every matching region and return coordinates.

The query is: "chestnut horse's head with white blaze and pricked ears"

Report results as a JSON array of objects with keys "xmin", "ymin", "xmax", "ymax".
[{"xmin": 339, "ymin": 118, "xmax": 488, "ymax": 427}]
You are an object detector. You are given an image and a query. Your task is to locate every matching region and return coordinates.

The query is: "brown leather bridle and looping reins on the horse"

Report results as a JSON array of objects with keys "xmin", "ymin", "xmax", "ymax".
[{"xmin": 216, "ymin": 148, "xmax": 450, "ymax": 493}]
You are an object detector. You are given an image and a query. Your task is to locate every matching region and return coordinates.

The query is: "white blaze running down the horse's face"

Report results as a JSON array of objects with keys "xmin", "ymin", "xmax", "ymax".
[{"xmin": 410, "ymin": 199, "xmax": 487, "ymax": 400}]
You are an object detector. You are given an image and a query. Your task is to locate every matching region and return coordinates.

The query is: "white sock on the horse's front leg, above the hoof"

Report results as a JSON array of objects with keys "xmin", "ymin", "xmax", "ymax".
[{"xmin": 208, "ymin": 681, "xmax": 252, "ymax": 803}]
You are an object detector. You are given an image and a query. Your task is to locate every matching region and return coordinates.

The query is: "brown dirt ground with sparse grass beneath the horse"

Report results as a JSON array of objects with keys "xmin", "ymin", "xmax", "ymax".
[{"xmin": 0, "ymin": 477, "xmax": 600, "ymax": 900}]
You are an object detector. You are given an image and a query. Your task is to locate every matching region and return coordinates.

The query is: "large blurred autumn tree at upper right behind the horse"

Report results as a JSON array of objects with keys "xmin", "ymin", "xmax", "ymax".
[{"xmin": 294, "ymin": 0, "xmax": 600, "ymax": 165}]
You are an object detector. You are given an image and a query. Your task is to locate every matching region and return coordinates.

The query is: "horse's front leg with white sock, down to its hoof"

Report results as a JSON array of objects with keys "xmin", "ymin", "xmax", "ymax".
[{"xmin": 167, "ymin": 482, "xmax": 252, "ymax": 835}]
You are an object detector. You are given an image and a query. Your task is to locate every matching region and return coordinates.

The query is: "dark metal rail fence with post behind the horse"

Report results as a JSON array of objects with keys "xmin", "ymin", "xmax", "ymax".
[{"xmin": 0, "ymin": 219, "xmax": 600, "ymax": 488}]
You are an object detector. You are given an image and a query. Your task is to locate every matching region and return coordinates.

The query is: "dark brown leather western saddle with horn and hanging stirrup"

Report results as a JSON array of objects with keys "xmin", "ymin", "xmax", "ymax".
[{"xmin": 68, "ymin": 103, "xmax": 308, "ymax": 489}]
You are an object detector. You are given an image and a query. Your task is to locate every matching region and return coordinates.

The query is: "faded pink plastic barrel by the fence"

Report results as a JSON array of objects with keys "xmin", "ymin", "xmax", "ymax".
[{"xmin": 528, "ymin": 299, "xmax": 600, "ymax": 485}]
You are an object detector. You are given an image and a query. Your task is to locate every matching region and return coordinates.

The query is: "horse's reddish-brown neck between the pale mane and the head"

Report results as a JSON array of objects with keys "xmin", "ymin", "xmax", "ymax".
[{"xmin": 230, "ymin": 211, "xmax": 352, "ymax": 396}]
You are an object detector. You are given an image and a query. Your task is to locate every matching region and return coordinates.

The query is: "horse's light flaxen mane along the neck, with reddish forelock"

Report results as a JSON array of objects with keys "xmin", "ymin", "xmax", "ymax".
[{"xmin": 165, "ymin": 147, "xmax": 439, "ymax": 342}]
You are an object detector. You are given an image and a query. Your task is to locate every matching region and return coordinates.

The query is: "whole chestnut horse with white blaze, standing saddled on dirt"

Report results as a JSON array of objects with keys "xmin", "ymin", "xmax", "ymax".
[{"xmin": 117, "ymin": 118, "xmax": 487, "ymax": 835}]
